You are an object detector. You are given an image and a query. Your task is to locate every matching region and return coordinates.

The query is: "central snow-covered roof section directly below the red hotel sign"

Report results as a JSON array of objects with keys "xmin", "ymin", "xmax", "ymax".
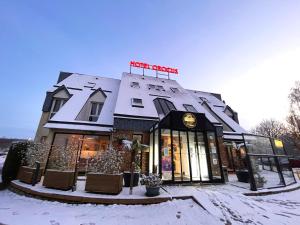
[{"xmin": 115, "ymin": 73, "xmax": 223, "ymax": 123}]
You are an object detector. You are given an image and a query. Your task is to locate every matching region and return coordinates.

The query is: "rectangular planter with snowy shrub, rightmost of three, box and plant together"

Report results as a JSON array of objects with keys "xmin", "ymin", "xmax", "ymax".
[{"xmin": 85, "ymin": 148, "xmax": 123, "ymax": 194}]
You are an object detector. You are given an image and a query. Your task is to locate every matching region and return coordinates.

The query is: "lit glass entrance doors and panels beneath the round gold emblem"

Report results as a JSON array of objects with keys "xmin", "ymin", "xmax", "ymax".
[{"xmin": 149, "ymin": 129, "xmax": 222, "ymax": 182}]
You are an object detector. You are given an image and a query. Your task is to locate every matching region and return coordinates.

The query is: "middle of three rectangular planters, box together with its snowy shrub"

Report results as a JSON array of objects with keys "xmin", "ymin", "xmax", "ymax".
[{"xmin": 43, "ymin": 141, "xmax": 78, "ymax": 190}]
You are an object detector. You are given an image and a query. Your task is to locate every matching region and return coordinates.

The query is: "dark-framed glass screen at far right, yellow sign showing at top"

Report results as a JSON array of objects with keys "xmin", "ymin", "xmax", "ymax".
[{"xmin": 243, "ymin": 135, "xmax": 295, "ymax": 190}]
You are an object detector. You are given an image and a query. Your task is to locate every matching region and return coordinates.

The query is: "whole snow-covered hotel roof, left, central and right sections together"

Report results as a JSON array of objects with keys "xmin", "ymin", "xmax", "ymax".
[{"xmin": 45, "ymin": 73, "xmax": 245, "ymax": 133}]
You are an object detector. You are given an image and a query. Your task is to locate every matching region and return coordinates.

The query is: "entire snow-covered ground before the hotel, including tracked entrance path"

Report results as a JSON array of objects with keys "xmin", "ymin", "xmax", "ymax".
[{"xmin": 0, "ymin": 184, "xmax": 300, "ymax": 225}]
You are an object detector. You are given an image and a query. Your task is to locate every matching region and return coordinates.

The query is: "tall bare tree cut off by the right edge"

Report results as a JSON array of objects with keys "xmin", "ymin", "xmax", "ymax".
[{"xmin": 287, "ymin": 81, "xmax": 300, "ymax": 148}]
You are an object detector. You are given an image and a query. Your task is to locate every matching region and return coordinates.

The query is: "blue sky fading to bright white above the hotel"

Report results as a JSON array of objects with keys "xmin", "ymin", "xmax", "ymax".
[{"xmin": 0, "ymin": 0, "xmax": 300, "ymax": 137}]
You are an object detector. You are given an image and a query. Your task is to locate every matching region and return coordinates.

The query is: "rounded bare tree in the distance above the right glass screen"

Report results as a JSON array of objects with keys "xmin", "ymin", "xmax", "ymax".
[{"xmin": 251, "ymin": 119, "xmax": 286, "ymax": 138}]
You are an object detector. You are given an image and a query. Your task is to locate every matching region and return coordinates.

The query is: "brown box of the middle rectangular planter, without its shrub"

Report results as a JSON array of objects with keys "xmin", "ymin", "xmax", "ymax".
[{"xmin": 43, "ymin": 169, "xmax": 75, "ymax": 191}]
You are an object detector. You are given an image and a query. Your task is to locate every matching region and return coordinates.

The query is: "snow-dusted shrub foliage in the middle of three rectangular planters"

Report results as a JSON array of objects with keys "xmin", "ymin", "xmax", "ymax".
[{"xmin": 49, "ymin": 141, "xmax": 79, "ymax": 171}]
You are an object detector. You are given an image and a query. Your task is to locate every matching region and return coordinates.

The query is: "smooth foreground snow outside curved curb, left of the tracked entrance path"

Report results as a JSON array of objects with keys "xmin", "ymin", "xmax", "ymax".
[{"xmin": 0, "ymin": 190, "xmax": 223, "ymax": 225}]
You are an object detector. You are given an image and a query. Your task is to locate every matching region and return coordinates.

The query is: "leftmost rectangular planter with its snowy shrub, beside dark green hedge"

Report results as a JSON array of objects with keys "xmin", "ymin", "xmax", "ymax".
[{"xmin": 17, "ymin": 142, "xmax": 49, "ymax": 184}]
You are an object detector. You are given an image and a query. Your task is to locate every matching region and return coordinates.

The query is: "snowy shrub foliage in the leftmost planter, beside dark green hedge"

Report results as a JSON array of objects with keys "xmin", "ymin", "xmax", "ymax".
[{"xmin": 22, "ymin": 142, "xmax": 50, "ymax": 167}]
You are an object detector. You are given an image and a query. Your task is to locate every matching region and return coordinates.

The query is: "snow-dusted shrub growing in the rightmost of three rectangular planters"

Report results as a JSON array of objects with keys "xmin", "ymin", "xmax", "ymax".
[{"xmin": 89, "ymin": 148, "xmax": 123, "ymax": 174}]
